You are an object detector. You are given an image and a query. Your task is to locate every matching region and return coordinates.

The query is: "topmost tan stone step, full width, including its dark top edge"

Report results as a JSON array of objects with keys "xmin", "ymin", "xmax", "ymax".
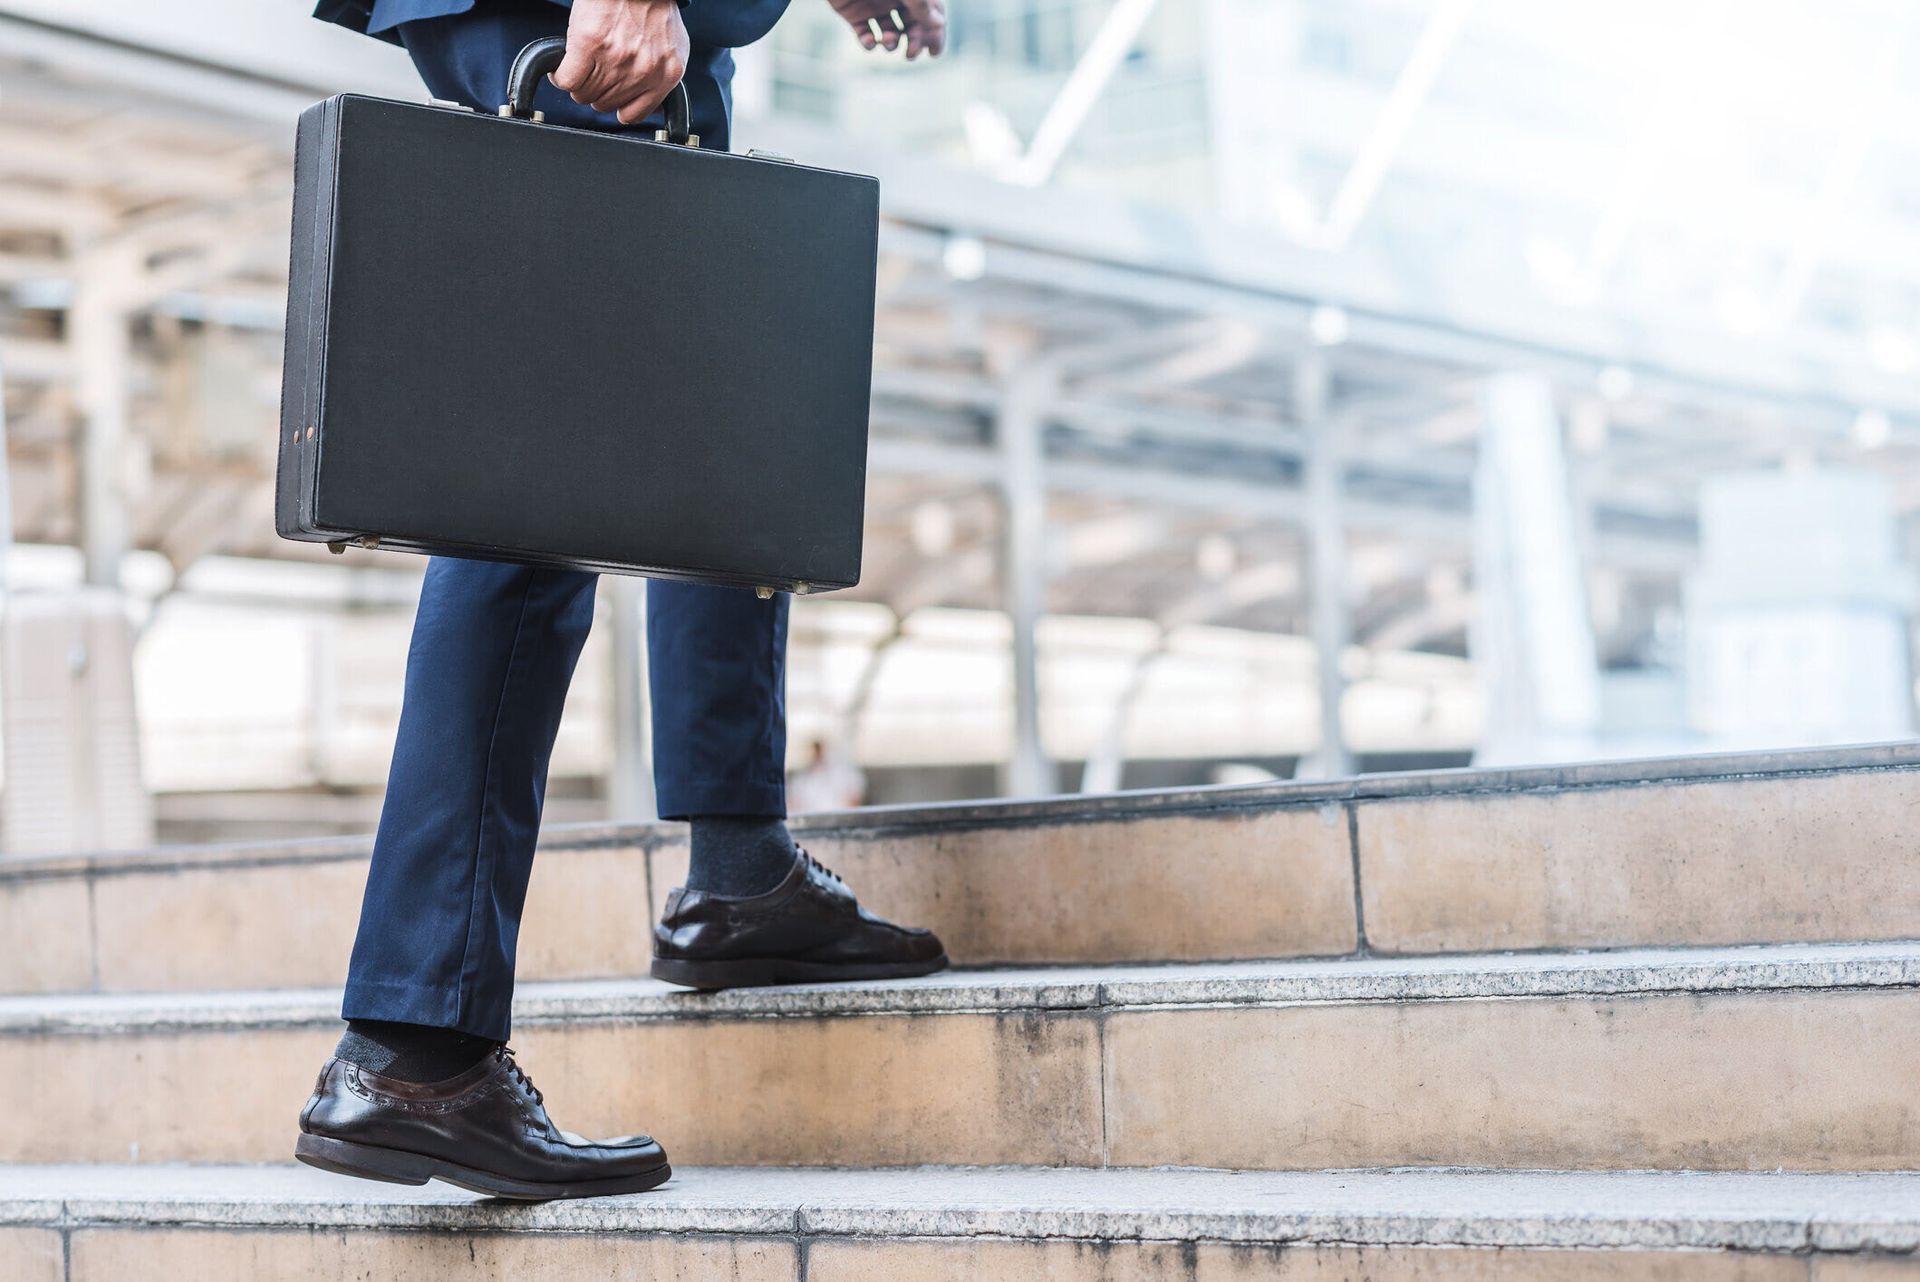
[{"xmin": 11, "ymin": 745, "xmax": 1920, "ymax": 992}]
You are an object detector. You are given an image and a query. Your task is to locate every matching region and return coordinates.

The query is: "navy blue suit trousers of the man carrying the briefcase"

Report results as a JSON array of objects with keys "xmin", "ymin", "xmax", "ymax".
[{"xmin": 342, "ymin": 4, "xmax": 789, "ymax": 1040}]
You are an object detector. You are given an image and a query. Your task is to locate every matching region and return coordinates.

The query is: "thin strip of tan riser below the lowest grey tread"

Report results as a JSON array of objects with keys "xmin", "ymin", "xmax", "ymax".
[{"xmin": 18, "ymin": 1226, "xmax": 1889, "ymax": 1282}]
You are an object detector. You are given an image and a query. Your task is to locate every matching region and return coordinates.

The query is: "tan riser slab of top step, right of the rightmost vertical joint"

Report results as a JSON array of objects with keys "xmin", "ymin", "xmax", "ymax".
[{"xmin": 1357, "ymin": 770, "xmax": 1920, "ymax": 954}]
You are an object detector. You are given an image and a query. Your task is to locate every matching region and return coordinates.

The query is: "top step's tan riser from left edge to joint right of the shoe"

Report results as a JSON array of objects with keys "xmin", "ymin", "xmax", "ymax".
[{"xmin": 0, "ymin": 806, "xmax": 1356, "ymax": 992}]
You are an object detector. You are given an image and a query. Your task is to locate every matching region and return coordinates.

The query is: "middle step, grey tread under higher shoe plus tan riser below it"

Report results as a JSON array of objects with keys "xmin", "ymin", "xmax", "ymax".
[{"xmin": 0, "ymin": 944, "xmax": 1920, "ymax": 1171}]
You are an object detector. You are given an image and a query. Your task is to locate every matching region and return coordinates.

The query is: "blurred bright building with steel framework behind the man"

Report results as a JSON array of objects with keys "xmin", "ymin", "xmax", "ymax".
[{"xmin": 0, "ymin": 0, "xmax": 1920, "ymax": 844}]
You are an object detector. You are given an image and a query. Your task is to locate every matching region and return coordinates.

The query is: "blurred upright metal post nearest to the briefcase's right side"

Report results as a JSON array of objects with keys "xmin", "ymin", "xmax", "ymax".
[{"xmin": 996, "ymin": 365, "xmax": 1058, "ymax": 796}]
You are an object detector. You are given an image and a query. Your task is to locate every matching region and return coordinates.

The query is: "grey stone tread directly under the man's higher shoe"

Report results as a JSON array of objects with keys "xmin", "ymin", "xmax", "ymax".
[{"xmin": 0, "ymin": 940, "xmax": 1920, "ymax": 1033}]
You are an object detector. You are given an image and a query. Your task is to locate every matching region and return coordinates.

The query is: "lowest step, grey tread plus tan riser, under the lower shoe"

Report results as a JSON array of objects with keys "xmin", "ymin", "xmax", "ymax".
[{"xmin": 0, "ymin": 1167, "xmax": 1920, "ymax": 1282}]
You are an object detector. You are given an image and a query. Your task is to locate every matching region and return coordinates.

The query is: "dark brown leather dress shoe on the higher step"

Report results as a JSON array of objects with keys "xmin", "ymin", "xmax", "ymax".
[{"xmin": 653, "ymin": 850, "xmax": 947, "ymax": 988}]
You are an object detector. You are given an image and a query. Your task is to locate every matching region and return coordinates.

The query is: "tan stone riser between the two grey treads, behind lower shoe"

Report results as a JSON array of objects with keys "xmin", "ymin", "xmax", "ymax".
[{"xmin": 0, "ymin": 988, "xmax": 1920, "ymax": 1171}]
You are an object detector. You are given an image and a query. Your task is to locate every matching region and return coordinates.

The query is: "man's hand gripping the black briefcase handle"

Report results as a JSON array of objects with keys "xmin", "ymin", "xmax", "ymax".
[{"xmin": 553, "ymin": 0, "xmax": 687, "ymax": 125}]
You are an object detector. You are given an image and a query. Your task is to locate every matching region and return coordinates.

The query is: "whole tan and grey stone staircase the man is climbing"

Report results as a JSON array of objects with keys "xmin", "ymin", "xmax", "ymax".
[{"xmin": 0, "ymin": 747, "xmax": 1920, "ymax": 1282}]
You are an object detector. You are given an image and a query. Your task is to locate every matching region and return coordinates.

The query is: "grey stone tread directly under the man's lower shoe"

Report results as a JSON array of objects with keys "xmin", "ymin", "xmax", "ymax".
[{"xmin": 0, "ymin": 1165, "xmax": 1920, "ymax": 1251}]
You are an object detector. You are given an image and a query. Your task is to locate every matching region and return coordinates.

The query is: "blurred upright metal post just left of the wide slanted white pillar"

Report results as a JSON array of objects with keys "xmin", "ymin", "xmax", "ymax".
[{"xmin": 1294, "ymin": 349, "xmax": 1354, "ymax": 779}]
